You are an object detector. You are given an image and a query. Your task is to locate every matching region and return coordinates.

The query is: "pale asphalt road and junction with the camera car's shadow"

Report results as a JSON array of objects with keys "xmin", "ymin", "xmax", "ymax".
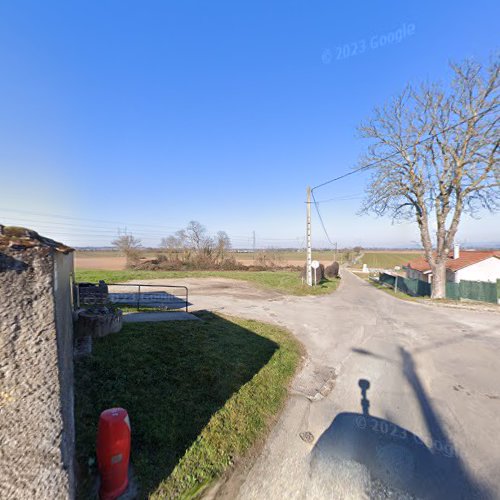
[{"xmin": 131, "ymin": 272, "xmax": 500, "ymax": 499}]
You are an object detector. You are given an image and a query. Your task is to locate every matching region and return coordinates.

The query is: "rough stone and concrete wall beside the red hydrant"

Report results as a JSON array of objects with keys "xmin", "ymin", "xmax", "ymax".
[{"xmin": 0, "ymin": 246, "xmax": 75, "ymax": 500}]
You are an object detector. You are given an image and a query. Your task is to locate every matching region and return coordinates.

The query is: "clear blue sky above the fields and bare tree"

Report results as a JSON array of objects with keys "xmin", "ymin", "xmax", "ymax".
[{"xmin": 0, "ymin": 0, "xmax": 500, "ymax": 246}]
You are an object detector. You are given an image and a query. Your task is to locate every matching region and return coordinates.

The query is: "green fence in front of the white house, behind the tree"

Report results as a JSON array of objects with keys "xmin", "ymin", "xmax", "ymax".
[{"xmin": 379, "ymin": 273, "xmax": 500, "ymax": 304}]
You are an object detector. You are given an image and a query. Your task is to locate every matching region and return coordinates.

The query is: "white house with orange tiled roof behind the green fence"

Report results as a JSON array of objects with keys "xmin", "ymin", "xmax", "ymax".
[{"xmin": 405, "ymin": 245, "xmax": 500, "ymax": 283}]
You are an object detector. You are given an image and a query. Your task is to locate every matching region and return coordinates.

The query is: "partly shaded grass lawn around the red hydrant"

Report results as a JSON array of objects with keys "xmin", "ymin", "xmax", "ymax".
[{"xmin": 75, "ymin": 313, "xmax": 301, "ymax": 498}]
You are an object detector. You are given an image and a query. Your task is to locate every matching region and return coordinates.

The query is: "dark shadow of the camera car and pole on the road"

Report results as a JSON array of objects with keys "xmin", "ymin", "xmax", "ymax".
[{"xmin": 311, "ymin": 348, "xmax": 491, "ymax": 499}]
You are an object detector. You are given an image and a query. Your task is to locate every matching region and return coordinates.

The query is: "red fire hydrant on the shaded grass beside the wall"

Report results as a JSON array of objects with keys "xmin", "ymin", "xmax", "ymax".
[{"xmin": 97, "ymin": 408, "xmax": 130, "ymax": 500}]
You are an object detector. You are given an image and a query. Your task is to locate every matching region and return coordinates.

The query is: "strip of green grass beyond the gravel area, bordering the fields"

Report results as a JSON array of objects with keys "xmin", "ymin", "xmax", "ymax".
[{"xmin": 75, "ymin": 269, "xmax": 339, "ymax": 295}]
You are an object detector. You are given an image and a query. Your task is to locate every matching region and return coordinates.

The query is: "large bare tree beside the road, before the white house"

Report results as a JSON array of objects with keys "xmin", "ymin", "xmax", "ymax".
[{"xmin": 360, "ymin": 58, "xmax": 500, "ymax": 298}]
